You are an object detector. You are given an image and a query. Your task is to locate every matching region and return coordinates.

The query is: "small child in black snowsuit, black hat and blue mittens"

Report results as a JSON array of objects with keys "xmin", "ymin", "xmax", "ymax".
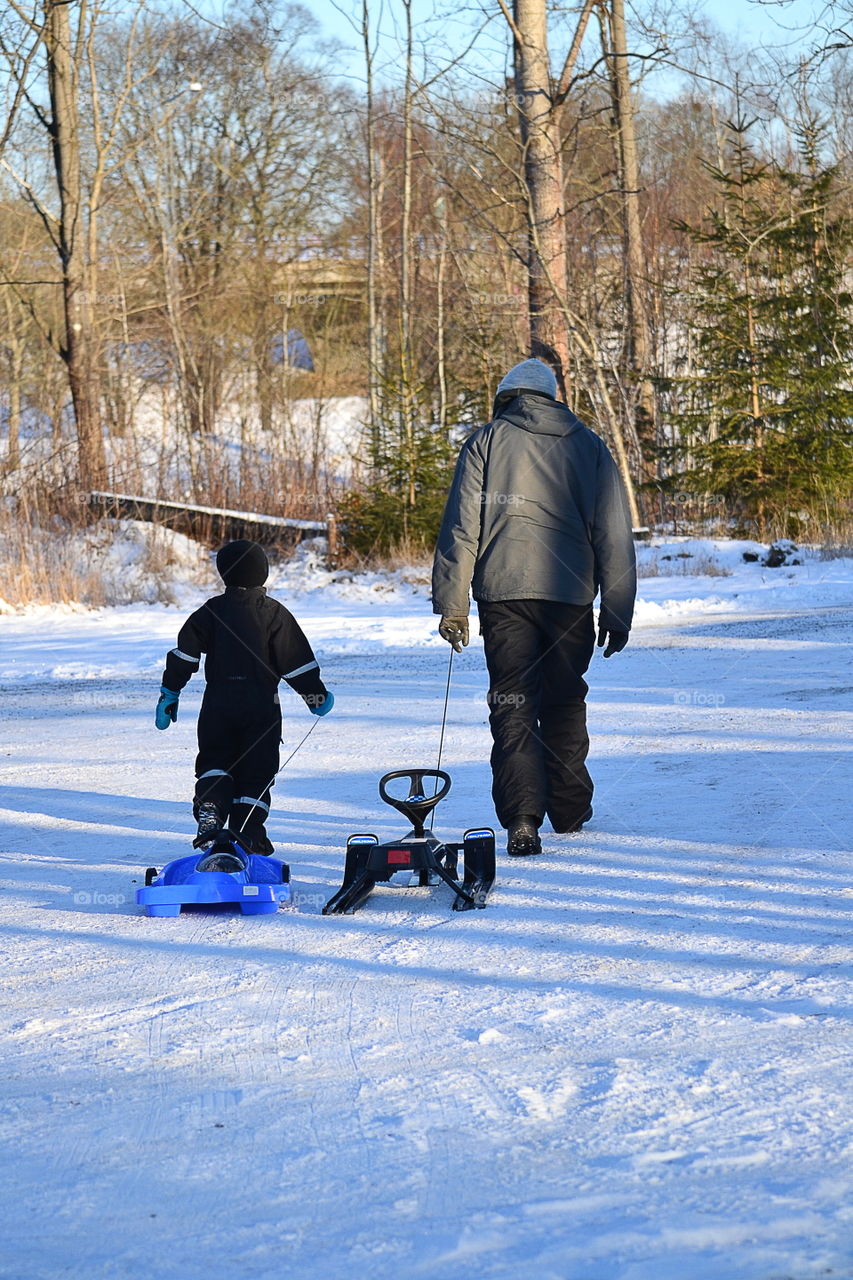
[{"xmin": 155, "ymin": 539, "xmax": 334, "ymax": 854}]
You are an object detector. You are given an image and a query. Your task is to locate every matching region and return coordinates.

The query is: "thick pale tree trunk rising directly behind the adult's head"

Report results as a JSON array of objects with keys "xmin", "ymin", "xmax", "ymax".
[{"xmin": 512, "ymin": 0, "xmax": 569, "ymax": 399}]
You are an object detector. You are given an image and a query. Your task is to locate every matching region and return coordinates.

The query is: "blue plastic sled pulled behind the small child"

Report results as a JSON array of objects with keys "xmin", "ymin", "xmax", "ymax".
[{"xmin": 136, "ymin": 832, "xmax": 291, "ymax": 915}]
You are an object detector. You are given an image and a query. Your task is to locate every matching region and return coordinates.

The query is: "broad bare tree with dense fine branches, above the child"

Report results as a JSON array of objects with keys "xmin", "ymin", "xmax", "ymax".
[{"xmin": 106, "ymin": 5, "xmax": 350, "ymax": 450}]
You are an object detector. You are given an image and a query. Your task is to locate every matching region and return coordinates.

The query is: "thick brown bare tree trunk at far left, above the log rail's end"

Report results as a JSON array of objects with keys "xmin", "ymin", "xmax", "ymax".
[{"xmin": 45, "ymin": 0, "xmax": 106, "ymax": 490}]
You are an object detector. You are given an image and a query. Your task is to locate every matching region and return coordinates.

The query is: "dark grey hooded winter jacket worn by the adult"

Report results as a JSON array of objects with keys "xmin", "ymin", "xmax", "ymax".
[{"xmin": 433, "ymin": 392, "xmax": 637, "ymax": 631}]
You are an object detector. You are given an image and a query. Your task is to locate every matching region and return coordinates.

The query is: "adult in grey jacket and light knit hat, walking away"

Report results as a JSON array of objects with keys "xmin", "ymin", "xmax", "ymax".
[{"xmin": 433, "ymin": 360, "xmax": 637, "ymax": 855}]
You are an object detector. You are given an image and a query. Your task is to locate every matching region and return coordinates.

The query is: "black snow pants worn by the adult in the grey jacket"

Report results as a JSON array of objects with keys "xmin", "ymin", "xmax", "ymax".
[{"xmin": 478, "ymin": 600, "xmax": 596, "ymax": 831}]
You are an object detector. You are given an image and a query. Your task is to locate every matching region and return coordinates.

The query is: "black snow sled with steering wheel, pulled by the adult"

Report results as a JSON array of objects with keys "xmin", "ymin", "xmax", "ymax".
[{"xmin": 323, "ymin": 769, "xmax": 494, "ymax": 915}]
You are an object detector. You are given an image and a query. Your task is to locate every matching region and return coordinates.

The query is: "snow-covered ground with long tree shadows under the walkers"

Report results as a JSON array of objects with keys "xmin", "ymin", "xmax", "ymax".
[{"xmin": 0, "ymin": 543, "xmax": 853, "ymax": 1280}]
